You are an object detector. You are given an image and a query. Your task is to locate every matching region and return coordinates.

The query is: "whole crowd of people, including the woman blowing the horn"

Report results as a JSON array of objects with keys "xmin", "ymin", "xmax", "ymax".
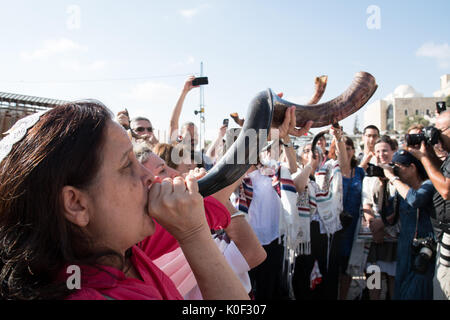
[{"xmin": 0, "ymin": 77, "xmax": 450, "ymax": 301}]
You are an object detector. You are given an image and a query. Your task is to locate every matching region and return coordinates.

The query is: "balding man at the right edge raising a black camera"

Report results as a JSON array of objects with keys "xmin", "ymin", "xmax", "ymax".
[{"xmin": 408, "ymin": 111, "xmax": 450, "ymax": 299}]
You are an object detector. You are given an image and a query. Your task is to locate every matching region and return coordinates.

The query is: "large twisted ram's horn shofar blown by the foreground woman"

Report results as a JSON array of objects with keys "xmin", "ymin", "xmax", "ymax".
[{"xmin": 198, "ymin": 72, "xmax": 377, "ymax": 197}]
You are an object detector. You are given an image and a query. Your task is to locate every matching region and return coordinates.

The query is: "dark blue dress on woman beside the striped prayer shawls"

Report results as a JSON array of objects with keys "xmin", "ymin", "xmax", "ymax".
[{"xmin": 339, "ymin": 167, "xmax": 365, "ymax": 258}]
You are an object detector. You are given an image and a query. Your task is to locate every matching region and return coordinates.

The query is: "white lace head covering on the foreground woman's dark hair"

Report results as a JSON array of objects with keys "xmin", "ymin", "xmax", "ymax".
[{"xmin": 0, "ymin": 109, "xmax": 51, "ymax": 163}]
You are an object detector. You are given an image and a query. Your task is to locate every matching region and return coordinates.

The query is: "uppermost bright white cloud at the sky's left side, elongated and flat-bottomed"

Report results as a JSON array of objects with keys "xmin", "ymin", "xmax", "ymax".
[{"xmin": 20, "ymin": 38, "xmax": 87, "ymax": 61}]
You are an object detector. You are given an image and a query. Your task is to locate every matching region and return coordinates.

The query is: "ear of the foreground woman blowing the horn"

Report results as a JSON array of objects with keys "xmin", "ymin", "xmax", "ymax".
[{"xmin": 61, "ymin": 186, "xmax": 89, "ymax": 227}]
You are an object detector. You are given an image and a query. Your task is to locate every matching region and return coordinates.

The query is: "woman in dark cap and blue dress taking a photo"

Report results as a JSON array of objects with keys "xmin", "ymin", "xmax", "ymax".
[{"xmin": 381, "ymin": 150, "xmax": 436, "ymax": 300}]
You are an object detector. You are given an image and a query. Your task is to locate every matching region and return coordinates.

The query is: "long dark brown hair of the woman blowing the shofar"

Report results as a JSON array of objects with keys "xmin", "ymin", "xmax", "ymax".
[{"xmin": 0, "ymin": 100, "xmax": 123, "ymax": 299}]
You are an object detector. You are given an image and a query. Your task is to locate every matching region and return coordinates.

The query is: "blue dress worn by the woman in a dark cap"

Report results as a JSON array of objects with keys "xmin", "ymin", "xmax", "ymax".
[{"xmin": 389, "ymin": 180, "xmax": 436, "ymax": 300}]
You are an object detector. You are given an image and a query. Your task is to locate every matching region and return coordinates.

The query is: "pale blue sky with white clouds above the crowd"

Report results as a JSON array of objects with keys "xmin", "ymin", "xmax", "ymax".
[{"xmin": 0, "ymin": 0, "xmax": 450, "ymax": 139}]
